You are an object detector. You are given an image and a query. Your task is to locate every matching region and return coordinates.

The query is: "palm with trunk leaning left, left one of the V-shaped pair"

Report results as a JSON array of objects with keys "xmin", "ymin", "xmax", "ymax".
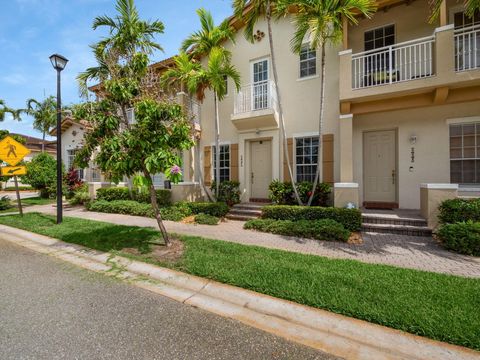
[{"xmin": 233, "ymin": 0, "xmax": 302, "ymax": 205}]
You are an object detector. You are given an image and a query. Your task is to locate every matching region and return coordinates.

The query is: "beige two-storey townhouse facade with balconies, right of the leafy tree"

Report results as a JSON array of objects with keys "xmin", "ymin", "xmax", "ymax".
[{"xmin": 196, "ymin": 0, "xmax": 480, "ymax": 209}]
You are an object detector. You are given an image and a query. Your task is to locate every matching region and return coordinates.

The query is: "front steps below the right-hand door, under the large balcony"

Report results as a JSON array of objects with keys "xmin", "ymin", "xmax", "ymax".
[{"xmin": 362, "ymin": 212, "xmax": 432, "ymax": 237}]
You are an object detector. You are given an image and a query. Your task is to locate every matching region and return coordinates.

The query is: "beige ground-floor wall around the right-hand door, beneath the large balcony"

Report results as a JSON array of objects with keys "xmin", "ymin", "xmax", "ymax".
[{"xmin": 353, "ymin": 102, "xmax": 480, "ymax": 209}]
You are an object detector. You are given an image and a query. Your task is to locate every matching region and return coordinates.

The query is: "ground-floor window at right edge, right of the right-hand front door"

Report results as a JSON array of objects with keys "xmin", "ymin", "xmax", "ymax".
[{"xmin": 450, "ymin": 122, "xmax": 480, "ymax": 184}]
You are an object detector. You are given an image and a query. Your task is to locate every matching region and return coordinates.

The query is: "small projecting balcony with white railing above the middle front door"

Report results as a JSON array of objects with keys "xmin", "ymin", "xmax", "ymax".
[{"xmin": 231, "ymin": 81, "xmax": 278, "ymax": 130}]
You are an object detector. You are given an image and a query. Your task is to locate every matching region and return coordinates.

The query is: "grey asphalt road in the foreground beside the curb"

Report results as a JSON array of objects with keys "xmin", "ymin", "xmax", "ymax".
[{"xmin": 0, "ymin": 240, "xmax": 333, "ymax": 360}]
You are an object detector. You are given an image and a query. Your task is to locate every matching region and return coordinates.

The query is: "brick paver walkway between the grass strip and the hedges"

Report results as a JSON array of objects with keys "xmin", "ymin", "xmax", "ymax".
[{"xmin": 26, "ymin": 205, "xmax": 480, "ymax": 278}]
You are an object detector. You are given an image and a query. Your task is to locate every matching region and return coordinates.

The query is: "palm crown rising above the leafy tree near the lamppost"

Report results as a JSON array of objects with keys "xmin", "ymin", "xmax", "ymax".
[{"xmin": 77, "ymin": 0, "xmax": 165, "ymax": 93}]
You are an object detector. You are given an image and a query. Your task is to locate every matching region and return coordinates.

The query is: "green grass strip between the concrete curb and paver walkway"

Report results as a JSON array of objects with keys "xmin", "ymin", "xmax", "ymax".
[{"xmin": 0, "ymin": 214, "xmax": 480, "ymax": 350}]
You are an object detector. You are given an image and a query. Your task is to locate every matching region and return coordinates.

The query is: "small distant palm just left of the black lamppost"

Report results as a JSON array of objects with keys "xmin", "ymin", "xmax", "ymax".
[{"xmin": 25, "ymin": 96, "xmax": 57, "ymax": 152}]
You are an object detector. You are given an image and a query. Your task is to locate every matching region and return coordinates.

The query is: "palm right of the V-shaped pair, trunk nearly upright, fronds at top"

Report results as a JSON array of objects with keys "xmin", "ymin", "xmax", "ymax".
[{"xmin": 284, "ymin": 0, "xmax": 376, "ymax": 206}]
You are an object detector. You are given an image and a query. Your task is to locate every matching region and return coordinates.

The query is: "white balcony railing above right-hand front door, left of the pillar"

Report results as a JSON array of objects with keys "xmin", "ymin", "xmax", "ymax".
[{"xmin": 352, "ymin": 36, "xmax": 435, "ymax": 89}]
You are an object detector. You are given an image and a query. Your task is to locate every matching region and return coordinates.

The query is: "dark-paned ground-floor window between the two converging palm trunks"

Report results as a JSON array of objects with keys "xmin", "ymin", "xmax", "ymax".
[{"xmin": 295, "ymin": 136, "xmax": 318, "ymax": 182}]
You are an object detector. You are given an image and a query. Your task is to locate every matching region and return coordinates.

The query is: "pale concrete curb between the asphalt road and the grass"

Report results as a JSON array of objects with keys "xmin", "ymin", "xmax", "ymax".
[{"xmin": 0, "ymin": 225, "xmax": 480, "ymax": 360}]
